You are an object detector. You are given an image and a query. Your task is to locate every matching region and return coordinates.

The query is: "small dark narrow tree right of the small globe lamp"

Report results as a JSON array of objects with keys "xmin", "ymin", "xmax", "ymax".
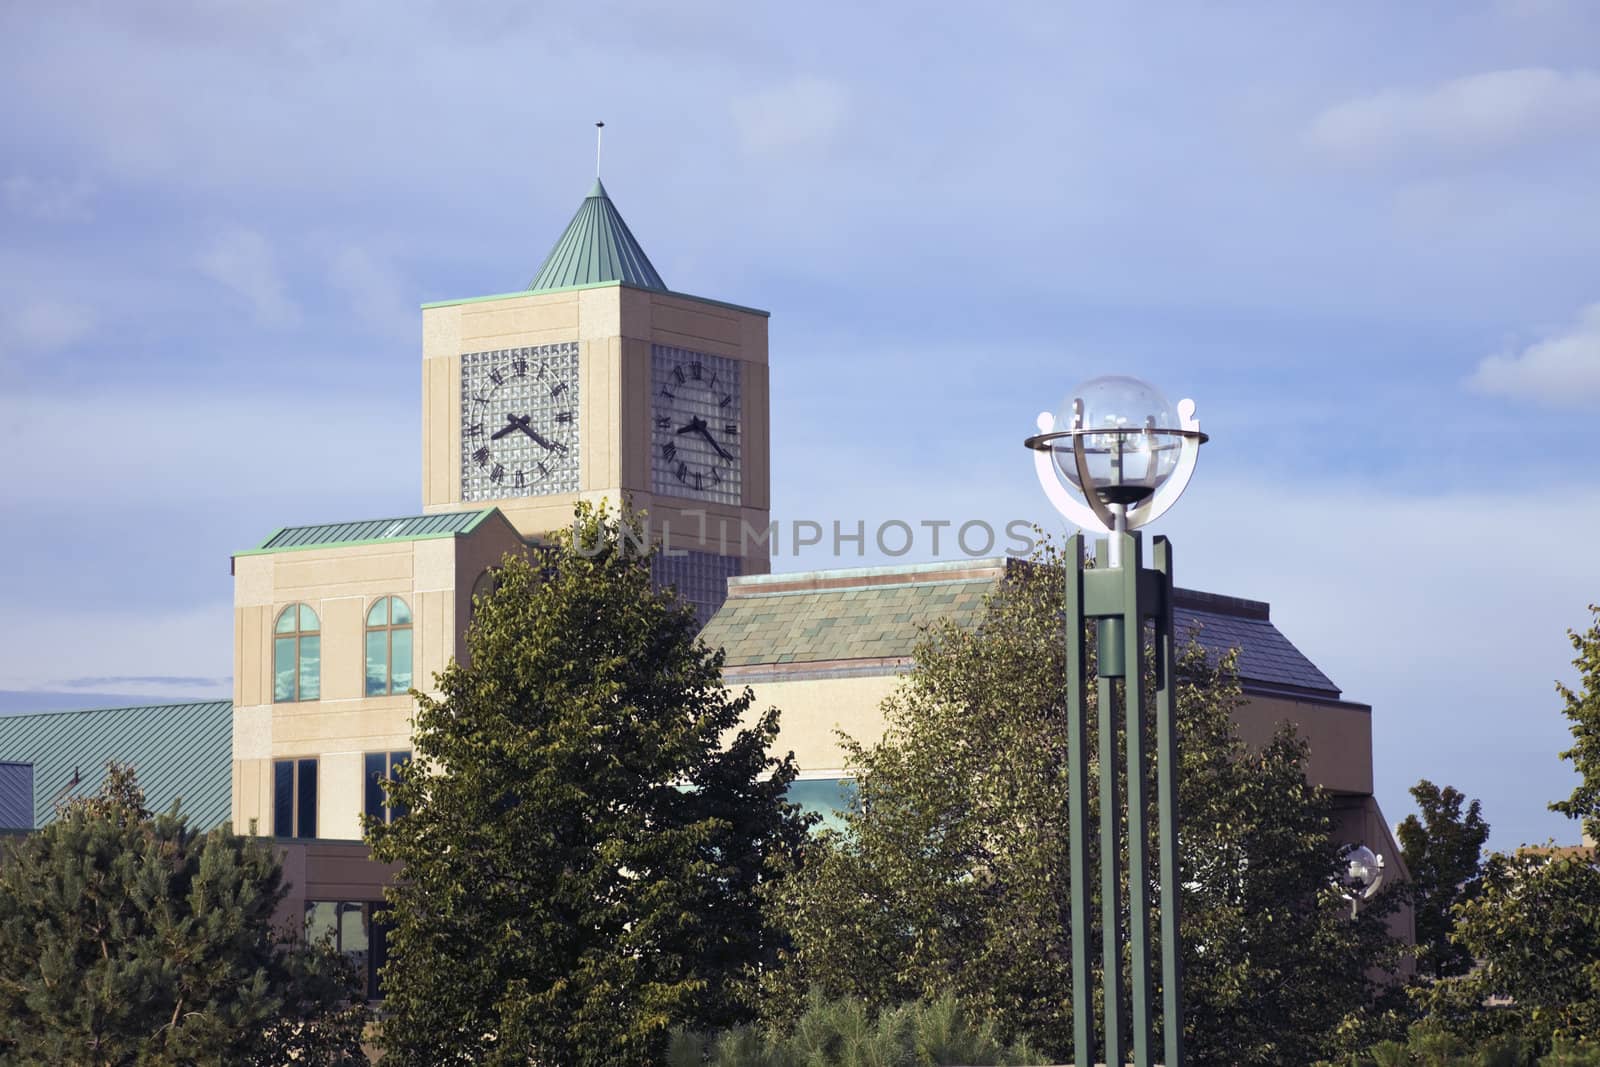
[{"xmin": 1398, "ymin": 779, "xmax": 1490, "ymax": 977}]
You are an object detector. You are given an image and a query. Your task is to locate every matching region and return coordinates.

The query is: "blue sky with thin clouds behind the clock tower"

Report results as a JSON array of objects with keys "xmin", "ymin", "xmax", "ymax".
[{"xmin": 0, "ymin": 0, "xmax": 1600, "ymax": 848}]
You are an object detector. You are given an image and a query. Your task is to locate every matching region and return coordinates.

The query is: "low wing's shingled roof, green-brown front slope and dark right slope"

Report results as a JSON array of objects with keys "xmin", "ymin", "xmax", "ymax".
[{"xmin": 701, "ymin": 558, "xmax": 1339, "ymax": 699}]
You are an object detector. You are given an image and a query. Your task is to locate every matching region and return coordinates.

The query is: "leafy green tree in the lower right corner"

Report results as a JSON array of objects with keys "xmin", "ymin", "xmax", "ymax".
[{"xmin": 1421, "ymin": 849, "xmax": 1600, "ymax": 1049}]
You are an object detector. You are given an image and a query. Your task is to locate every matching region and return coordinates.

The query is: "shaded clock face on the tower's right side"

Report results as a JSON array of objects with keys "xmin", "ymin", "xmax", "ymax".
[{"xmin": 650, "ymin": 344, "xmax": 744, "ymax": 504}]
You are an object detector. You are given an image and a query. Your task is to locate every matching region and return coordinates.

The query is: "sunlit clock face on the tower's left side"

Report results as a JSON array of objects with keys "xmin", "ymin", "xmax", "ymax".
[{"xmin": 461, "ymin": 341, "xmax": 578, "ymax": 501}]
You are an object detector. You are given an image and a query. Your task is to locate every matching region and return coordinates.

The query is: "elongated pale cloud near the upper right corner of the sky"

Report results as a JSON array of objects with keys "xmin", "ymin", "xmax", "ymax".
[{"xmin": 1306, "ymin": 67, "xmax": 1600, "ymax": 163}]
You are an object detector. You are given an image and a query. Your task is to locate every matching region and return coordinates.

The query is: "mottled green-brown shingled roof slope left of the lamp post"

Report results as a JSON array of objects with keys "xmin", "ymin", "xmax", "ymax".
[{"xmin": 701, "ymin": 573, "xmax": 1000, "ymax": 667}]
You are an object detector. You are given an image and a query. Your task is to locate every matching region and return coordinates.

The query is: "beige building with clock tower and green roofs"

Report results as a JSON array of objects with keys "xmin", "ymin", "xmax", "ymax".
[{"xmin": 0, "ymin": 181, "xmax": 1398, "ymax": 995}]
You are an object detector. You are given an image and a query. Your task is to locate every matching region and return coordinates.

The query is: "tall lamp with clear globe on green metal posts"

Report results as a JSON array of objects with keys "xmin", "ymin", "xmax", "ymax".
[{"xmin": 1024, "ymin": 376, "xmax": 1206, "ymax": 1067}]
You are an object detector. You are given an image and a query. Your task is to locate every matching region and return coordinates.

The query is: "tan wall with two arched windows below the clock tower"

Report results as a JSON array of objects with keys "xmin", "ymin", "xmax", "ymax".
[{"xmin": 232, "ymin": 517, "xmax": 523, "ymax": 838}]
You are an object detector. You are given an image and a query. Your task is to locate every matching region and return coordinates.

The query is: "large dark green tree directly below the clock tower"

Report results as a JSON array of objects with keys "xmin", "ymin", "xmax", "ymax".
[{"xmin": 366, "ymin": 506, "xmax": 806, "ymax": 1067}]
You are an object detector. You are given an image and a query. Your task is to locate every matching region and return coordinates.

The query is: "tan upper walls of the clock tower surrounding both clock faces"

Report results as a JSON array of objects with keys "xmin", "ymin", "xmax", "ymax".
[{"xmin": 422, "ymin": 286, "xmax": 771, "ymax": 556}]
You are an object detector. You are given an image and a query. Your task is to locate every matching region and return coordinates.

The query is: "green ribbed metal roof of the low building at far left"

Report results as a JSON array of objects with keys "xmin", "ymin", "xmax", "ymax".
[{"xmin": 0, "ymin": 701, "xmax": 234, "ymax": 830}]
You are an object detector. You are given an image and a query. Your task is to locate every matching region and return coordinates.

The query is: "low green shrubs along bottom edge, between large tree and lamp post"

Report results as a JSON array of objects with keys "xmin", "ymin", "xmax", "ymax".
[{"xmin": 667, "ymin": 992, "xmax": 1048, "ymax": 1067}]
